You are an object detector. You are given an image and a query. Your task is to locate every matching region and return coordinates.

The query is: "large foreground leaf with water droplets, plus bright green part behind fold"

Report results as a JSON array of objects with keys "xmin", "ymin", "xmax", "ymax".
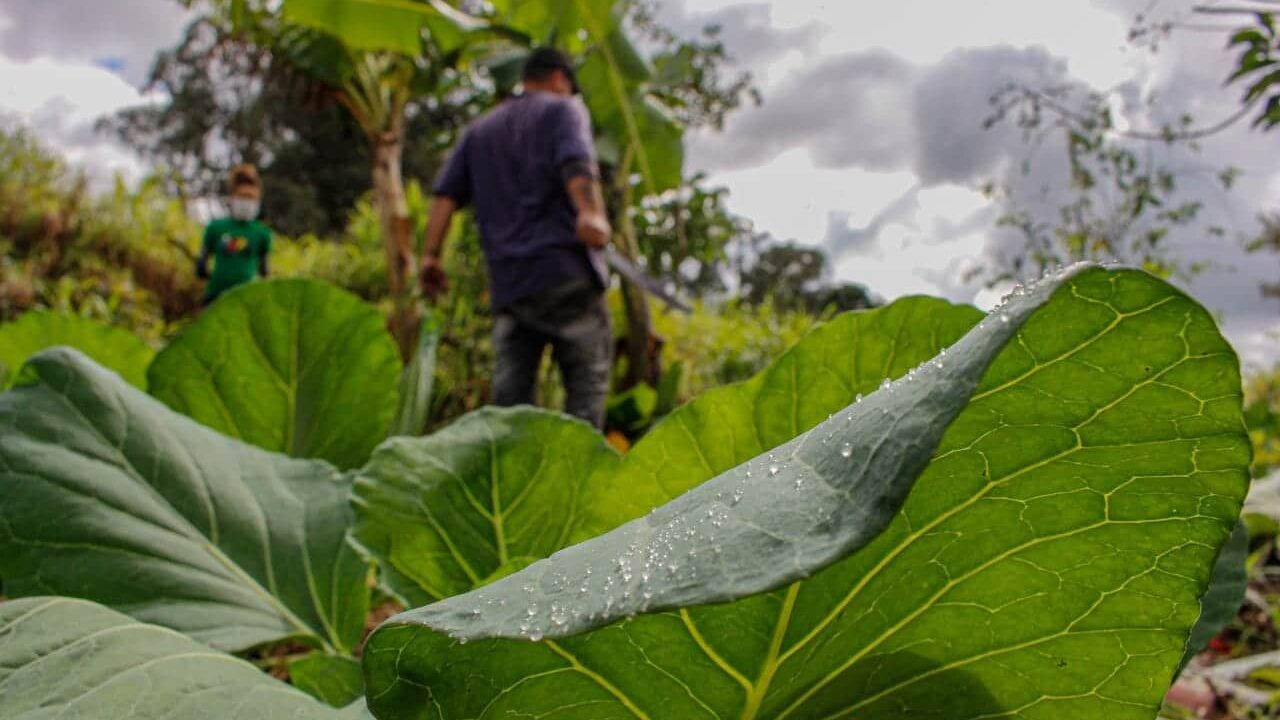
[{"xmin": 365, "ymin": 269, "xmax": 1249, "ymax": 720}]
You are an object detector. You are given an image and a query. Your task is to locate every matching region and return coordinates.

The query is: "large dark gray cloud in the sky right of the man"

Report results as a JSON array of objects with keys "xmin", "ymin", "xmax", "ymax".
[{"xmin": 692, "ymin": 46, "xmax": 1068, "ymax": 186}]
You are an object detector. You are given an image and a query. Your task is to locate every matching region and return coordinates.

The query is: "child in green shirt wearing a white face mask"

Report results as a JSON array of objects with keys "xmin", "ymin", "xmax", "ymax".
[{"xmin": 196, "ymin": 165, "xmax": 271, "ymax": 305}]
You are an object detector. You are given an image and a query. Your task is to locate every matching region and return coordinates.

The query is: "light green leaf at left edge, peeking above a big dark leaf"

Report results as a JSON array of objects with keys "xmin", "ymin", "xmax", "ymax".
[{"xmin": 0, "ymin": 311, "xmax": 155, "ymax": 389}]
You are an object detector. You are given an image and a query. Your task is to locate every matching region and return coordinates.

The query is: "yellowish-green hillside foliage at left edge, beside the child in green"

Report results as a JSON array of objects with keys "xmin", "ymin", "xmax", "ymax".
[{"xmin": 0, "ymin": 128, "xmax": 200, "ymax": 343}]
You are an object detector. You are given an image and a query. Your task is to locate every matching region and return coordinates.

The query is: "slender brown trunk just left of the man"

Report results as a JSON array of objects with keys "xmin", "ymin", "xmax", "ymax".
[{"xmin": 372, "ymin": 114, "xmax": 419, "ymax": 363}]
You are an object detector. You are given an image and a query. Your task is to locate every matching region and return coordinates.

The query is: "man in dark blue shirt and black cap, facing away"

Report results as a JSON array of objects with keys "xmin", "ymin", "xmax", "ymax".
[{"xmin": 419, "ymin": 49, "xmax": 613, "ymax": 428}]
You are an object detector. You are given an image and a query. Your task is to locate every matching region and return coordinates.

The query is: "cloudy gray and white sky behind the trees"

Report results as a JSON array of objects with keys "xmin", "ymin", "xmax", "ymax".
[{"xmin": 0, "ymin": 0, "xmax": 1280, "ymax": 364}]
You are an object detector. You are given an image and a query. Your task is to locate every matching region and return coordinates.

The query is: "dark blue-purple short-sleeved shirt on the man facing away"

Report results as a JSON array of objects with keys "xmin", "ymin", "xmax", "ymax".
[{"xmin": 434, "ymin": 92, "xmax": 608, "ymax": 310}]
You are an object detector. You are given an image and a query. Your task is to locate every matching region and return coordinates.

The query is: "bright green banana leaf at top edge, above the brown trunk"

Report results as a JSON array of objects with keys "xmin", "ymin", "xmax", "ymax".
[{"xmin": 284, "ymin": 0, "xmax": 485, "ymax": 58}]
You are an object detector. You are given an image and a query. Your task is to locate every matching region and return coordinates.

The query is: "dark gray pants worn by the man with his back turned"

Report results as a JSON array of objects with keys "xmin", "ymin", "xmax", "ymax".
[{"xmin": 493, "ymin": 281, "xmax": 613, "ymax": 428}]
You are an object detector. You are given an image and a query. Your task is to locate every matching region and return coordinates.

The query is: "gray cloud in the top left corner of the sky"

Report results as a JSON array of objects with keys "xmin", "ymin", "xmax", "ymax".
[{"xmin": 0, "ymin": 0, "xmax": 189, "ymax": 85}]
